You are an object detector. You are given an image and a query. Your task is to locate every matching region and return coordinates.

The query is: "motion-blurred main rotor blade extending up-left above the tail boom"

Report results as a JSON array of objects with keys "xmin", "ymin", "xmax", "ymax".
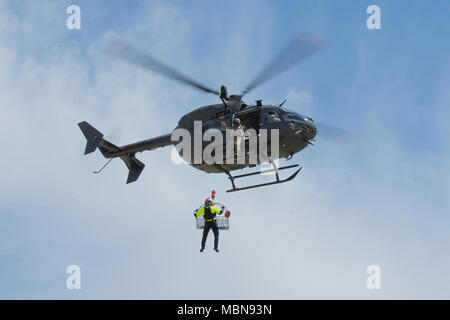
[{"xmin": 107, "ymin": 40, "xmax": 219, "ymax": 95}]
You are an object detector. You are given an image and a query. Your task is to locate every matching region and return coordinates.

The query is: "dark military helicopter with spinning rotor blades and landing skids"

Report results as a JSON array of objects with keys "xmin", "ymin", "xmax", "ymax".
[{"xmin": 78, "ymin": 34, "xmax": 347, "ymax": 192}]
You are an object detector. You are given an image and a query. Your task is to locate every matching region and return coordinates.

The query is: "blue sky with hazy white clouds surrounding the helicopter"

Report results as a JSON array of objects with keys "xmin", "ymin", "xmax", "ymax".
[{"xmin": 0, "ymin": 0, "xmax": 450, "ymax": 299}]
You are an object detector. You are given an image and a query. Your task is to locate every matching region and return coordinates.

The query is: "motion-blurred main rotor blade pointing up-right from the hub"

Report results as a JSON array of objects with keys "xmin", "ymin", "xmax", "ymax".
[{"xmin": 242, "ymin": 33, "xmax": 326, "ymax": 95}]
